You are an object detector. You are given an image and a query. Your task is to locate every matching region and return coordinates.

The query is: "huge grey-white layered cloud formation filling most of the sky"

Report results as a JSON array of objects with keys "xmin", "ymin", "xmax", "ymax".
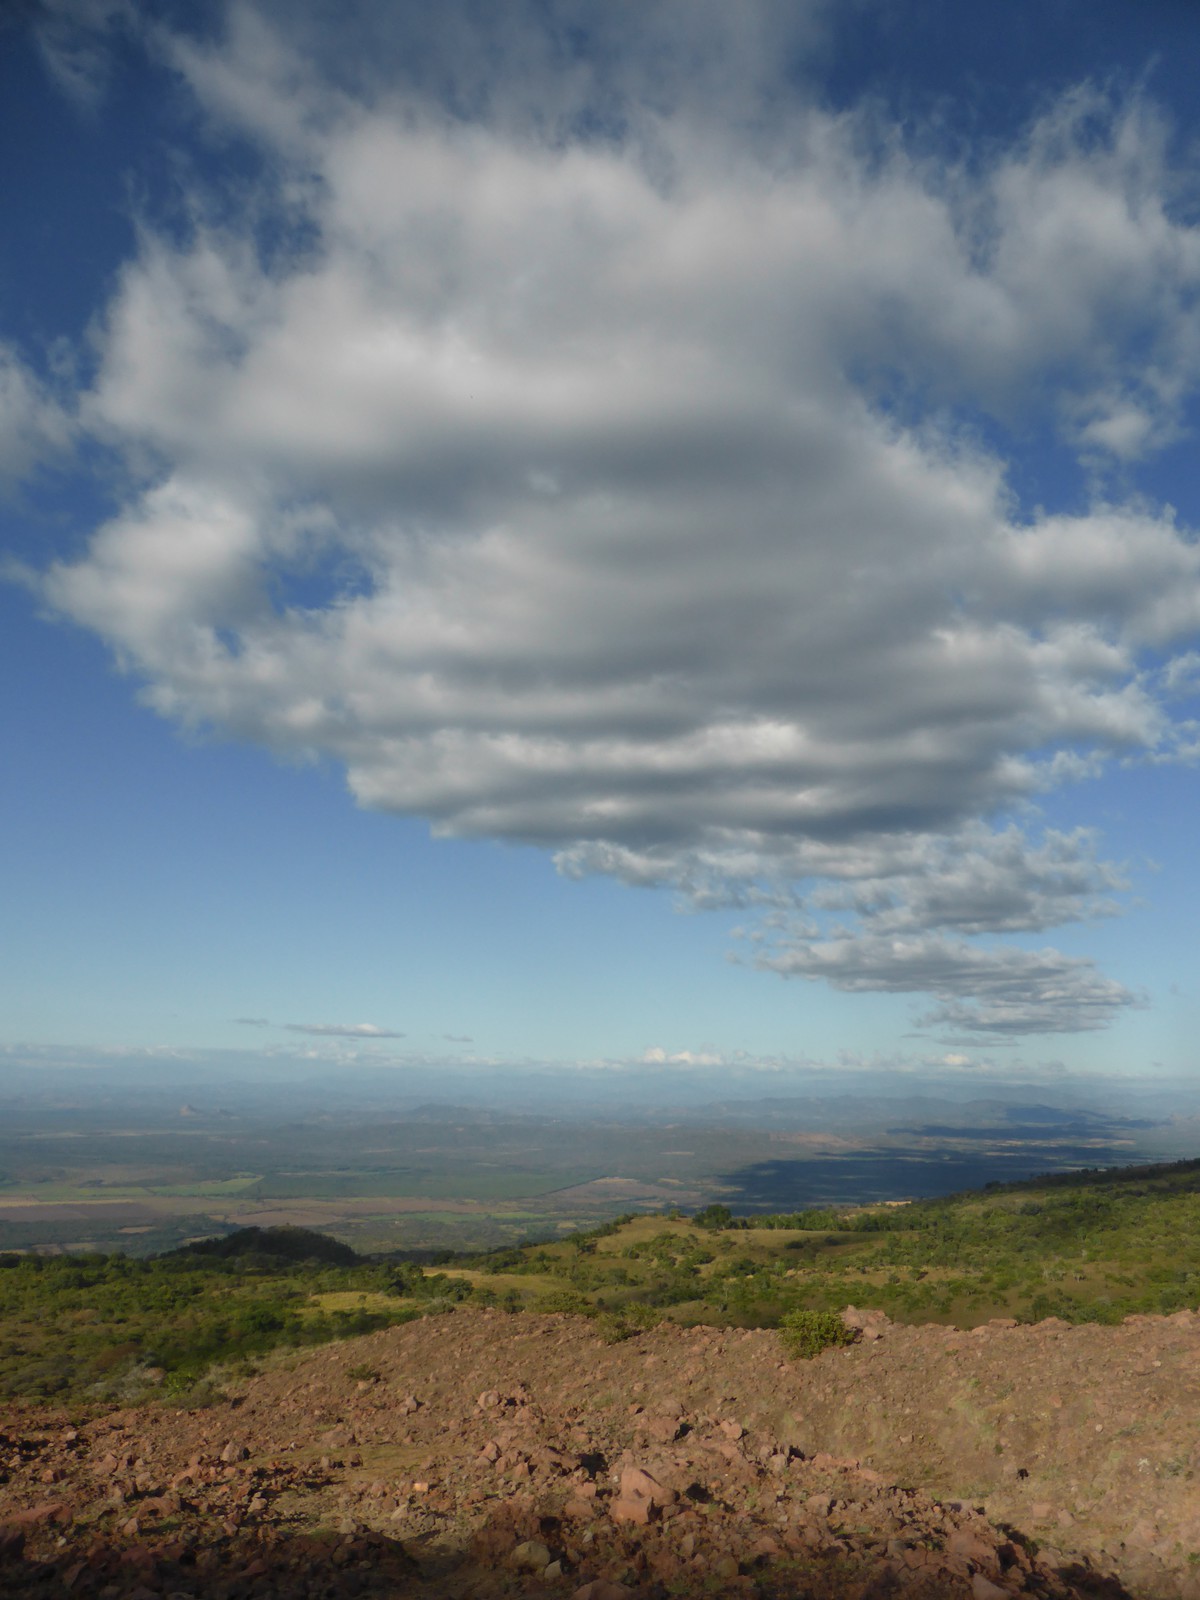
[{"xmin": 28, "ymin": 5, "xmax": 1200, "ymax": 1035}]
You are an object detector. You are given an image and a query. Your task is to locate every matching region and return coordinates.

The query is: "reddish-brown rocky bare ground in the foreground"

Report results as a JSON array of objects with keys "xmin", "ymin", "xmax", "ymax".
[{"xmin": 0, "ymin": 1310, "xmax": 1200, "ymax": 1600}]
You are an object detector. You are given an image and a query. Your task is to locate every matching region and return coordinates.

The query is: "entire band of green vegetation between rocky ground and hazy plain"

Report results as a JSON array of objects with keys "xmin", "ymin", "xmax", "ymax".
[{"xmin": 0, "ymin": 1162, "xmax": 1200, "ymax": 1400}]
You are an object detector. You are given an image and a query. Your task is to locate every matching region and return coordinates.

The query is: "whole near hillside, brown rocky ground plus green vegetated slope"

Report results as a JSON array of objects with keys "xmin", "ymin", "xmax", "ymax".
[{"xmin": 0, "ymin": 1163, "xmax": 1200, "ymax": 1600}]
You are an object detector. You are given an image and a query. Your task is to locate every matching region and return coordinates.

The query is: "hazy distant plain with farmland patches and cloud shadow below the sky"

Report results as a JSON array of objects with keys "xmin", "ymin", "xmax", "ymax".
[{"xmin": 0, "ymin": 1069, "xmax": 1200, "ymax": 1254}]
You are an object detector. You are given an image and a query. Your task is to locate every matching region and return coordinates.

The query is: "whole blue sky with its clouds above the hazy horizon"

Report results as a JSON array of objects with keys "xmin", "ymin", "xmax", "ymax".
[{"xmin": 0, "ymin": 0, "xmax": 1200, "ymax": 1077}]
